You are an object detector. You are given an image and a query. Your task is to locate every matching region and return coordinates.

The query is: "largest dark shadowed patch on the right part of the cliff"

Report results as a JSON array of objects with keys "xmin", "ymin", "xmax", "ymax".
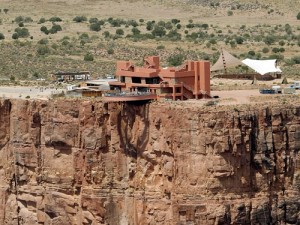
[{"xmin": 215, "ymin": 113, "xmax": 259, "ymax": 197}]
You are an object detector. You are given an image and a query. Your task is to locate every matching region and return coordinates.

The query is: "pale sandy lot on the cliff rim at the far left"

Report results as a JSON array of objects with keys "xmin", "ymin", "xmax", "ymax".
[{"xmin": 0, "ymin": 86, "xmax": 64, "ymax": 99}]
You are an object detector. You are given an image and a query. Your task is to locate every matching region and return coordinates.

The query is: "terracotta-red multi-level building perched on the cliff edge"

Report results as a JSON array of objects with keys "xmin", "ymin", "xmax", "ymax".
[{"xmin": 108, "ymin": 56, "xmax": 210, "ymax": 101}]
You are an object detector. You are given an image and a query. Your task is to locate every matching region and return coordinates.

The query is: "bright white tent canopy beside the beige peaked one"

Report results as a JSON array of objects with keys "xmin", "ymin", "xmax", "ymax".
[{"xmin": 242, "ymin": 59, "xmax": 282, "ymax": 75}]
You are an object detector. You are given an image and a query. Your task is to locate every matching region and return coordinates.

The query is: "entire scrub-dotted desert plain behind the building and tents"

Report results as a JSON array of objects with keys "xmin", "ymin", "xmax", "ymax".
[{"xmin": 0, "ymin": 0, "xmax": 300, "ymax": 82}]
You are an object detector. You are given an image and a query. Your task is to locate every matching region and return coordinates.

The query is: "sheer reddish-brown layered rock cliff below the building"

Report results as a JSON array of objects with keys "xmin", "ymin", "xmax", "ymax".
[{"xmin": 0, "ymin": 100, "xmax": 300, "ymax": 225}]
